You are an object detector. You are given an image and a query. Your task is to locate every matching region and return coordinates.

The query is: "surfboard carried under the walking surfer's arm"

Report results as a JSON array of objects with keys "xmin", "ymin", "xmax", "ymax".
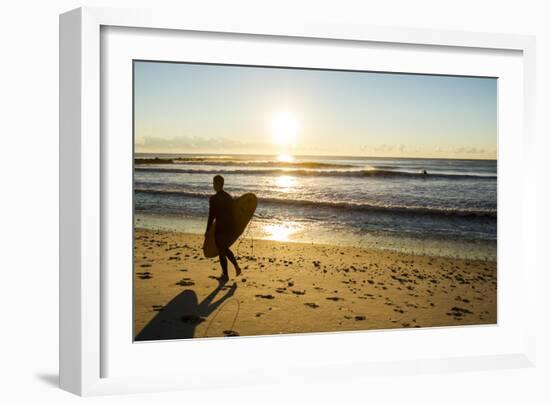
[{"xmin": 202, "ymin": 193, "xmax": 258, "ymax": 258}]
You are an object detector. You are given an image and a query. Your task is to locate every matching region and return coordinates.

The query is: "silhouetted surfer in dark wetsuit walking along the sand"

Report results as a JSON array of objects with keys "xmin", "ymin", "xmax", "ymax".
[{"xmin": 204, "ymin": 175, "xmax": 241, "ymax": 282}]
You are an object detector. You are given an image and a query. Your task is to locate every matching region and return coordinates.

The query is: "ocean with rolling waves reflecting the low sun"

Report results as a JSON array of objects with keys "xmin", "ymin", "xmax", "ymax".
[{"xmin": 134, "ymin": 154, "xmax": 497, "ymax": 260}]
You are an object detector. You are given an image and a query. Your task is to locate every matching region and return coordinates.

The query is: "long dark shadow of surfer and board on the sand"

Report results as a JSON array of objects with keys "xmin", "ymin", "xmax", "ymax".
[{"xmin": 135, "ymin": 283, "xmax": 237, "ymax": 341}]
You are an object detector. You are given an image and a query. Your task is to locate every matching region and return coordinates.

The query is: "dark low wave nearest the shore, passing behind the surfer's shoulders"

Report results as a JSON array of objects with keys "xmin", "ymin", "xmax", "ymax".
[{"xmin": 135, "ymin": 188, "xmax": 497, "ymax": 218}]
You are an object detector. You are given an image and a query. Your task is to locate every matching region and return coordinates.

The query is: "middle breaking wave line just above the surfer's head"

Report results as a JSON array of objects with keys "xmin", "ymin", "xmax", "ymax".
[{"xmin": 135, "ymin": 167, "xmax": 497, "ymax": 180}]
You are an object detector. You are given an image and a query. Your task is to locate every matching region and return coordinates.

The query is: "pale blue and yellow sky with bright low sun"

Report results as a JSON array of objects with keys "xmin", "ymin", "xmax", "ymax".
[{"xmin": 134, "ymin": 61, "xmax": 497, "ymax": 159}]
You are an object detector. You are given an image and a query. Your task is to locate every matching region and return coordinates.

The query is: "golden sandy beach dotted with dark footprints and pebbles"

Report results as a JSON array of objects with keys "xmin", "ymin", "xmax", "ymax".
[{"xmin": 134, "ymin": 228, "xmax": 497, "ymax": 341}]
